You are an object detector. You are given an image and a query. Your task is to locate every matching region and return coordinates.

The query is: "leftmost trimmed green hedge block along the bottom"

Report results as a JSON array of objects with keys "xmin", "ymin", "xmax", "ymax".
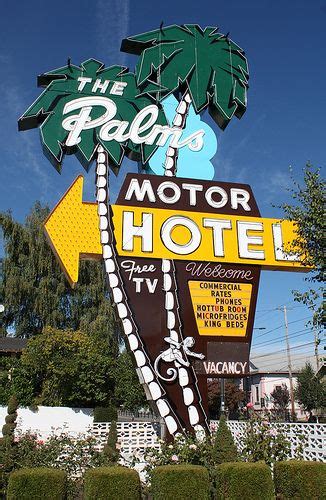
[{"xmin": 7, "ymin": 467, "xmax": 67, "ymax": 500}]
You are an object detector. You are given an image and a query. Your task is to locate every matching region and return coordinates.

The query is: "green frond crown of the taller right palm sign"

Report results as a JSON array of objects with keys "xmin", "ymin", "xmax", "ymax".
[{"xmin": 121, "ymin": 24, "xmax": 249, "ymax": 129}]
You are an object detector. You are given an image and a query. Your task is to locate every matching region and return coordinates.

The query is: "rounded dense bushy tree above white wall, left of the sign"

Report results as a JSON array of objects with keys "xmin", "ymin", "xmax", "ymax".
[{"xmin": 12, "ymin": 328, "xmax": 118, "ymax": 407}]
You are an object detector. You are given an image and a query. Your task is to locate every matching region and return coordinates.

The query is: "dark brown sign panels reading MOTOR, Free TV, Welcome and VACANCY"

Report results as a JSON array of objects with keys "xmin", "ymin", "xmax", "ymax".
[{"xmin": 112, "ymin": 174, "xmax": 260, "ymax": 430}]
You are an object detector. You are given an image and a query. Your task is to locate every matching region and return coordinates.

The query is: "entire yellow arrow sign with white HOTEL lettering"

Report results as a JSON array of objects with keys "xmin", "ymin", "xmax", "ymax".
[{"xmin": 45, "ymin": 176, "xmax": 309, "ymax": 286}]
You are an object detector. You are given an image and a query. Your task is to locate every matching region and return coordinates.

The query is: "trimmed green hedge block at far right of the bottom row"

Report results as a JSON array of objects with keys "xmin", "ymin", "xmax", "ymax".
[{"xmin": 274, "ymin": 460, "xmax": 326, "ymax": 500}]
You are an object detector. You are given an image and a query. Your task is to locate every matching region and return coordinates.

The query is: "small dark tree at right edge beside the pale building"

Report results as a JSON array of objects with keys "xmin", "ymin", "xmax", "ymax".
[{"xmin": 295, "ymin": 363, "xmax": 326, "ymax": 411}]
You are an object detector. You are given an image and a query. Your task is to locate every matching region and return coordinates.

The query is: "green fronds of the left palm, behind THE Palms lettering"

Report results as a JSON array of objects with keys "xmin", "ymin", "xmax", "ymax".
[{"xmin": 18, "ymin": 59, "xmax": 167, "ymax": 170}]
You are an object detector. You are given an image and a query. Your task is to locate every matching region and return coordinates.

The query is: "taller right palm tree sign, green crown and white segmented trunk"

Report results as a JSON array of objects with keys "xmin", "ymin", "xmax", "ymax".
[{"xmin": 121, "ymin": 24, "xmax": 249, "ymax": 430}]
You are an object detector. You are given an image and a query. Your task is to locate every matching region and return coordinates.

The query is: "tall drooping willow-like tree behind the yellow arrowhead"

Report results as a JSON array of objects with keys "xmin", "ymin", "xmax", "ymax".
[{"xmin": 0, "ymin": 203, "xmax": 119, "ymax": 342}]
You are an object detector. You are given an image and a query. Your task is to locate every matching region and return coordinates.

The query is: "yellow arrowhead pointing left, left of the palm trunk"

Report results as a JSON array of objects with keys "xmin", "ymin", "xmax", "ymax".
[{"xmin": 44, "ymin": 175, "xmax": 102, "ymax": 286}]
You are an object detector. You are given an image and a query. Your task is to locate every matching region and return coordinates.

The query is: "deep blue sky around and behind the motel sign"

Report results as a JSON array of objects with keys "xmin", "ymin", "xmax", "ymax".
[{"xmin": 0, "ymin": 0, "xmax": 326, "ymax": 369}]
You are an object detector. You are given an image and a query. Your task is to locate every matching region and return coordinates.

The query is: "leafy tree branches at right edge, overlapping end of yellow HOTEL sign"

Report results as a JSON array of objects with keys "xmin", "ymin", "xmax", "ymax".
[{"xmin": 281, "ymin": 163, "xmax": 326, "ymax": 328}]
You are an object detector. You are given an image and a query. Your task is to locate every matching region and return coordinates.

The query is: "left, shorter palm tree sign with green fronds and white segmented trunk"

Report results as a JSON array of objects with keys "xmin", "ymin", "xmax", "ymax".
[{"xmin": 18, "ymin": 59, "xmax": 187, "ymax": 434}]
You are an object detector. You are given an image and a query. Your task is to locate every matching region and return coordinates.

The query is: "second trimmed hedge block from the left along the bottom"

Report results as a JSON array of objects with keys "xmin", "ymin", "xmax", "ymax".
[{"xmin": 84, "ymin": 466, "xmax": 141, "ymax": 500}]
